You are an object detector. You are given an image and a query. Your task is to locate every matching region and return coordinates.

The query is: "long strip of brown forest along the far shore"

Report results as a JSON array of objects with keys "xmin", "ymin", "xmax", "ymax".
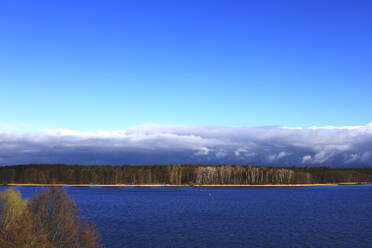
[{"xmin": 0, "ymin": 164, "xmax": 372, "ymax": 185}]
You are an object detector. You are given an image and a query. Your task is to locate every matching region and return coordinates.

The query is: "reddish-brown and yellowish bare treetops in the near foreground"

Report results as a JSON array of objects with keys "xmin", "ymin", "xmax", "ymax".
[{"xmin": 0, "ymin": 187, "xmax": 102, "ymax": 248}]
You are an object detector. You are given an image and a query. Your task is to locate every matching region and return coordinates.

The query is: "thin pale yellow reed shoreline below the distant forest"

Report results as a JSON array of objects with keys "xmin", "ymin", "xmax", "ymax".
[{"xmin": 2, "ymin": 182, "xmax": 369, "ymax": 187}]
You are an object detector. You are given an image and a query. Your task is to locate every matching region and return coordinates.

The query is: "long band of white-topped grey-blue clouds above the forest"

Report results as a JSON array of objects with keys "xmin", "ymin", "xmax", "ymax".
[{"xmin": 0, "ymin": 123, "xmax": 372, "ymax": 167}]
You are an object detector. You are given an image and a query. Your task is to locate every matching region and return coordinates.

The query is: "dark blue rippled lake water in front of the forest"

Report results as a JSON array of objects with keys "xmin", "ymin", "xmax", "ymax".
[{"xmin": 0, "ymin": 185, "xmax": 372, "ymax": 248}]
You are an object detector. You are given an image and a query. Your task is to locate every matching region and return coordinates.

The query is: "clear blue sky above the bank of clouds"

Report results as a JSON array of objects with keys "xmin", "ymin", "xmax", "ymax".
[{"xmin": 0, "ymin": 0, "xmax": 372, "ymax": 130}]
